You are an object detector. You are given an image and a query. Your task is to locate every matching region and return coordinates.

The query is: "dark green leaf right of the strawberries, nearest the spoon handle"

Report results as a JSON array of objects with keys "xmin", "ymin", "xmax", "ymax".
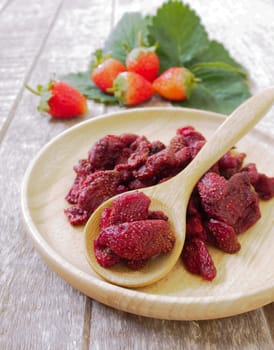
[{"xmin": 180, "ymin": 62, "xmax": 250, "ymax": 114}]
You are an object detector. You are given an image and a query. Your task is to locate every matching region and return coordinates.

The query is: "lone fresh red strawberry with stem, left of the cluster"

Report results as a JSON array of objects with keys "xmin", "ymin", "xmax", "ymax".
[{"xmin": 26, "ymin": 80, "xmax": 87, "ymax": 119}]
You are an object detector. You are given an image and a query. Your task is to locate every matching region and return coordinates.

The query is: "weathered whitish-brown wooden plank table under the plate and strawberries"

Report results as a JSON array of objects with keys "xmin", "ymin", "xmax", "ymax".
[{"xmin": 0, "ymin": 0, "xmax": 274, "ymax": 350}]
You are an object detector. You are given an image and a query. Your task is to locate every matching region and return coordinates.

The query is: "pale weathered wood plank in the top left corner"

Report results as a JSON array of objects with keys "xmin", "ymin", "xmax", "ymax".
[{"xmin": 0, "ymin": 0, "xmax": 61, "ymax": 139}]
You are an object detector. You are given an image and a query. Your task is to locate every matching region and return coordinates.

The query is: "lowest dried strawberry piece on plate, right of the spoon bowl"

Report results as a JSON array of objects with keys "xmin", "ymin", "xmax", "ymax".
[{"xmin": 182, "ymin": 238, "xmax": 216, "ymax": 281}]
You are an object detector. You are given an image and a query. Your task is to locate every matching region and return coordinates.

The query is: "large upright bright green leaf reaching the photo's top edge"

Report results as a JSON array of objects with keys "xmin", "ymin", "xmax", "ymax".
[{"xmin": 149, "ymin": 0, "xmax": 209, "ymax": 71}]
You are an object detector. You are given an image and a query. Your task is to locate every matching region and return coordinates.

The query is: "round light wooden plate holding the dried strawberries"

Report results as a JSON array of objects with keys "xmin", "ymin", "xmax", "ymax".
[{"xmin": 22, "ymin": 107, "xmax": 274, "ymax": 320}]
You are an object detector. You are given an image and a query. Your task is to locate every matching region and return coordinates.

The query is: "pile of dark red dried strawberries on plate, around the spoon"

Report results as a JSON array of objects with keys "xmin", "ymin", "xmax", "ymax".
[{"xmin": 65, "ymin": 126, "xmax": 274, "ymax": 280}]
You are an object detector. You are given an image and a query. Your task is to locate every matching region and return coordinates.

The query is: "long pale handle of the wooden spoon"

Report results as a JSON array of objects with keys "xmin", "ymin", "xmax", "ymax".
[{"xmin": 176, "ymin": 87, "xmax": 274, "ymax": 187}]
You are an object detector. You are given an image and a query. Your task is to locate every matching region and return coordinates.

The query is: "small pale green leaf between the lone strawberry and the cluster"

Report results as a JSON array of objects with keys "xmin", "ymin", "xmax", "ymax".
[{"xmin": 60, "ymin": 71, "xmax": 118, "ymax": 104}]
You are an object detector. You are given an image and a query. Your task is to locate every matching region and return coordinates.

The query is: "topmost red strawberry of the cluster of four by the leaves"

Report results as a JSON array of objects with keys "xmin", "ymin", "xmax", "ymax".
[{"xmin": 126, "ymin": 46, "xmax": 160, "ymax": 82}]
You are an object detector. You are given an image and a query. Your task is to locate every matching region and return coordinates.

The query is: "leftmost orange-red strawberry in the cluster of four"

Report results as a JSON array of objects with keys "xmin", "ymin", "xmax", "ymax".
[{"xmin": 91, "ymin": 58, "xmax": 126, "ymax": 93}]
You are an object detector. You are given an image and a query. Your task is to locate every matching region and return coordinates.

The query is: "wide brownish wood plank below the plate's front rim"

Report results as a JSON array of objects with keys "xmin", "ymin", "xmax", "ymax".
[{"xmin": 90, "ymin": 302, "xmax": 273, "ymax": 350}]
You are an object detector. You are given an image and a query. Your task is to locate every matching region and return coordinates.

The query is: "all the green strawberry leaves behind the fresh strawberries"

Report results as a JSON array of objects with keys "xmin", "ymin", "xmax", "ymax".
[{"xmin": 61, "ymin": 0, "xmax": 250, "ymax": 114}]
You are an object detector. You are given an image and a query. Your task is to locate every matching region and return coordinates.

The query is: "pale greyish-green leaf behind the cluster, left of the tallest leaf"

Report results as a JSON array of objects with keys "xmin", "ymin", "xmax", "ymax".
[{"xmin": 103, "ymin": 12, "xmax": 150, "ymax": 62}]
